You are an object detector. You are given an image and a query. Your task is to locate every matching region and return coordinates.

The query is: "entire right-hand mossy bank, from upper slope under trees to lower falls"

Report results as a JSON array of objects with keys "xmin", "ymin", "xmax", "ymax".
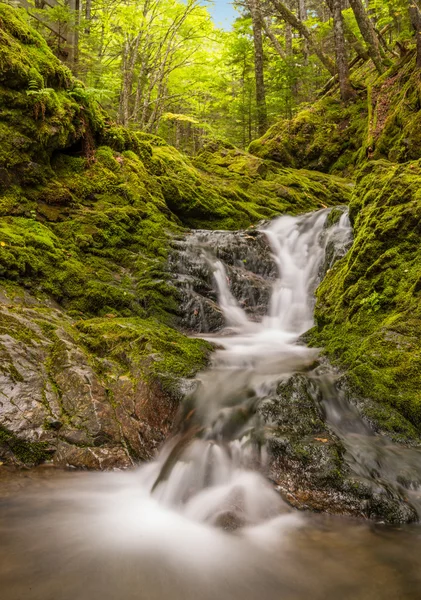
[{"xmin": 246, "ymin": 43, "xmax": 421, "ymax": 436}]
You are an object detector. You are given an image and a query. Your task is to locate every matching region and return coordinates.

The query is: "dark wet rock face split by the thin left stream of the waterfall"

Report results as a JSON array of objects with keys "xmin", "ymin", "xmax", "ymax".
[{"xmin": 169, "ymin": 229, "xmax": 277, "ymax": 333}]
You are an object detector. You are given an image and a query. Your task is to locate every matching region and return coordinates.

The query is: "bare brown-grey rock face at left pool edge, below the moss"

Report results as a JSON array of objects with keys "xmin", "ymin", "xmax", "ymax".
[{"xmin": 0, "ymin": 292, "xmax": 189, "ymax": 469}]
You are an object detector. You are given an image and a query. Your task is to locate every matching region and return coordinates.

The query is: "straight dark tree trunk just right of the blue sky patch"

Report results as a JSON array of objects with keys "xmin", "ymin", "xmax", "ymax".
[{"xmin": 249, "ymin": 0, "xmax": 267, "ymax": 136}]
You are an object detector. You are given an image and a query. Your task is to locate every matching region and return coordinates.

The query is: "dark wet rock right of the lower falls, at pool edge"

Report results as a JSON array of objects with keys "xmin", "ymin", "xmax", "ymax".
[{"xmin": 259, "ymin": 372, "xmax": 421, "ymax": 523}]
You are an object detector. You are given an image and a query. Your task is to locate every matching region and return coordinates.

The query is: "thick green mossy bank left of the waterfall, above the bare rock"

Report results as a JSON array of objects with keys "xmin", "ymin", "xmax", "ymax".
[{"xmin": 0, "ymin": 5, "xmax": 349, "ymax": 324}]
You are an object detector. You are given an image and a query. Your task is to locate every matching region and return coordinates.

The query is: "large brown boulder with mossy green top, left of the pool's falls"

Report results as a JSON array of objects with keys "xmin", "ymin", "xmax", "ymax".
[{"xmin": 0, "ymin": 286, "xmax": 211, "ymax": 468}]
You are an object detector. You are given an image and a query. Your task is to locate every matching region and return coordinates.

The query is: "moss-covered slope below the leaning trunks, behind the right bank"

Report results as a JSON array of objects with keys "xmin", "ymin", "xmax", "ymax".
[{"xmin": 249, "ymin": 53, "xmax": 421, "ymax": 174}]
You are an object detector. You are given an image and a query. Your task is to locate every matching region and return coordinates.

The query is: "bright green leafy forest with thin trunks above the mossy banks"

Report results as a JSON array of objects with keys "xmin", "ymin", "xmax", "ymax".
[{"xmin": 18, "ymin": 0, "xmax": 419, "ymax": 153}]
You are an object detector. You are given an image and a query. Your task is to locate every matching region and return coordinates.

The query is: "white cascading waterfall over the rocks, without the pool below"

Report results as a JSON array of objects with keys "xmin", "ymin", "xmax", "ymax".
[{"xmin": 148, "ymin": 210, "xmax": 351, "ymax": 528}]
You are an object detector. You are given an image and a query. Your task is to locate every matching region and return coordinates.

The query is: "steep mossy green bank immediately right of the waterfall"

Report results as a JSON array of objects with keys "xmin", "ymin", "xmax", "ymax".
[{"xmin": 312, "ymin": 160, "xmax": 421, "ymax": 437}]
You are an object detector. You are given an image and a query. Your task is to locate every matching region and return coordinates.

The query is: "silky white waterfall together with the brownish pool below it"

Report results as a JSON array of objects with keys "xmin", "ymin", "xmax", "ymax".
[{"xmin": 0, "ymin": 211, "xmax": 421, "ymax": 600}]
